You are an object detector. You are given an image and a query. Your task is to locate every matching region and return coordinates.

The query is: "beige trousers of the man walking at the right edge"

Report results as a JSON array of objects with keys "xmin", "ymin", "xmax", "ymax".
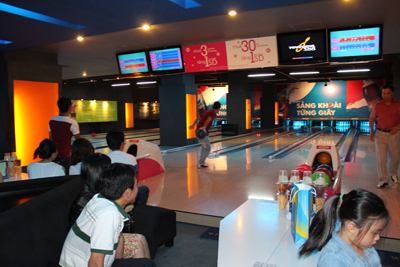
[{"xmin": 375, "ymin": 130, "xmax": 400, "ymax": 182}]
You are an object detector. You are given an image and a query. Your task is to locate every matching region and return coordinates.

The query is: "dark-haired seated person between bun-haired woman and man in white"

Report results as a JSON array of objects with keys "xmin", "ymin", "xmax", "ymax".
[{"xmin": 69, "ymin": 138, "xmax": 94, "ymax": 175}]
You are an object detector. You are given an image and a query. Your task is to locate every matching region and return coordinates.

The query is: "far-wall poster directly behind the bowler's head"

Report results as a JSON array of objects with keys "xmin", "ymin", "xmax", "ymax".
[{"xmin": 197, "ymin": 86, "xmax": 228, "ymax": 120}]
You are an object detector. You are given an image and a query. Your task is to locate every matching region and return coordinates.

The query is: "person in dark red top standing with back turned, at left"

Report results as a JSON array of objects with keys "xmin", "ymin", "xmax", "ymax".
[{"xmin": 49, "ymin": 97, "xmax": 81, "ymax": 175}]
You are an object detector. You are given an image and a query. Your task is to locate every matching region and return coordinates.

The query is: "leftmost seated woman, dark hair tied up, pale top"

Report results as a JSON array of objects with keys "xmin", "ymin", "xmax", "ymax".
[{"xmin": 28, "ymin": 138, "xmax": 65, "ymax": 179}]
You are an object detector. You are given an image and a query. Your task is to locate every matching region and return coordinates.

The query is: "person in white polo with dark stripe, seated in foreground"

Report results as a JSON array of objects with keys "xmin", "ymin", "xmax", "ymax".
[{"xmin": 59, "ymin": 162, "xmax": 155, "ymax": 266}]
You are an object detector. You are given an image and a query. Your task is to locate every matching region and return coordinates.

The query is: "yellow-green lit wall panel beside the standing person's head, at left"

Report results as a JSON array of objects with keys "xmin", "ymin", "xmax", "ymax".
[{"xmin": 71, "ymin": 100, "xmax": 118, "ymax": 123}]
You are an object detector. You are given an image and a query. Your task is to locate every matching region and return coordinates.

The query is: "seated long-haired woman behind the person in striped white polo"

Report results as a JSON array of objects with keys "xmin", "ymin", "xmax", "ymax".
[{"xmin": 69, "ymin": 154, "xmax": 150, "ymax": 259}]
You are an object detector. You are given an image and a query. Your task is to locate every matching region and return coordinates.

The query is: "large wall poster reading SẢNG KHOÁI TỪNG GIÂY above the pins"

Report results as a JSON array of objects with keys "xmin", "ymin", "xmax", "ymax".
[{"xmin": 277, "ymin": 79, "xmax": 385, "ymax": 119}]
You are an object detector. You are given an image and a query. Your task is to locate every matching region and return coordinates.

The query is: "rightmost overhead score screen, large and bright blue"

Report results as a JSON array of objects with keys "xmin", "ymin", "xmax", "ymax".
[{"xmin": 328, "ymin": 25, "xmax": 382, "ymax": 62}]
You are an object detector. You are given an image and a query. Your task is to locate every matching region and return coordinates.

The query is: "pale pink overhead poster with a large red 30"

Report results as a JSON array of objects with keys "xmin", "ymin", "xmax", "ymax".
[{"xmin": 225, "ymin": 36, "xmax": 278, "ymax": 70}]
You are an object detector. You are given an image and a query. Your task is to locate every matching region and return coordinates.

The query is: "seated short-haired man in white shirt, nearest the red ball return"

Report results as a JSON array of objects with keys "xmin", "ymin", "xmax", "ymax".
[{"xmin": 106, "ymin": 129, "xmax": 150, "ymax": 205}]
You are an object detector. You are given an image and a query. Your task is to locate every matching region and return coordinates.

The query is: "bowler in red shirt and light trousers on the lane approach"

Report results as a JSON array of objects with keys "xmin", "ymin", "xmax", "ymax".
[{"xmin": 190, "ymin": 101, "xmax": 221, "ymax": 168}]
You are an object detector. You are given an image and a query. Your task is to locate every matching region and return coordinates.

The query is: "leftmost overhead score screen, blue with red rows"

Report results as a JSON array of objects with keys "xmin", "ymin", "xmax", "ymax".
[{"xmin": 117, "ymin": 51, "xmax": 149, "ymax": 74}]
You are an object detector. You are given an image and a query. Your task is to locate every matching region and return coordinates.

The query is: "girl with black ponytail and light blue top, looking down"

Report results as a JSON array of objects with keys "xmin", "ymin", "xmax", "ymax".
[{"xmin": 299, "ymin": 189, "xmax": 390, "ymax": 267}]
